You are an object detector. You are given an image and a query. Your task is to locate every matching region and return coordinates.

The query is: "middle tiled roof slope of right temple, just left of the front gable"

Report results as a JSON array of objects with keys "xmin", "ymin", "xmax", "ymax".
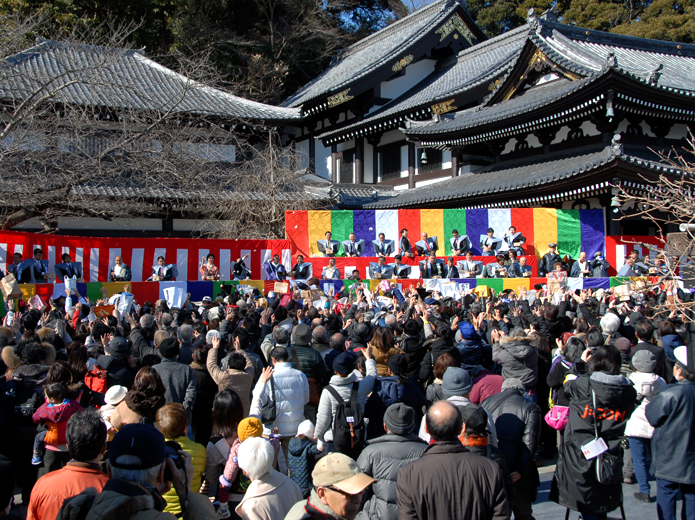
[{"xmin": 320, "ymin": 27, "xmax": 528, "ymax": 139}]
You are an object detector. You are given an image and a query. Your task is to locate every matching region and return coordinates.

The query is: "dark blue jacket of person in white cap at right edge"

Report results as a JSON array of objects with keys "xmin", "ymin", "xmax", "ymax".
[{"xmin": 645, "ymin": 379, "xmax": 695, "ymax": 484}]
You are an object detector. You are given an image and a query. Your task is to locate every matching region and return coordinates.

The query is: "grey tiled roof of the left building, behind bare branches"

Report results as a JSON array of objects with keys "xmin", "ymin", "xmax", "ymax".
[{"xmin": 0, "ymin": 41, "xmax": 301, "ymax": 121}]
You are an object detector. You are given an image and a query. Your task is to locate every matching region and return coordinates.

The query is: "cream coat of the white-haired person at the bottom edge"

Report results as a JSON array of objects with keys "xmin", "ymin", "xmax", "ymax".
[{"xmin": 235, "ymin": 469, "xmax": 302, "ymax": 520}]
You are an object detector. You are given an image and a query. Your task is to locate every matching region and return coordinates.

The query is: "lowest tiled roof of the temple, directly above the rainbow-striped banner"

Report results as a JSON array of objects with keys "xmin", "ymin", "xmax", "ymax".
[{"xmin": 363, "ymin": 145, "xmax": 668, "ymax": 209}]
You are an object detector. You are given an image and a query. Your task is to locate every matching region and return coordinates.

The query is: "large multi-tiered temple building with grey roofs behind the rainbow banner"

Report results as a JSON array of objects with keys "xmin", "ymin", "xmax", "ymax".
[{"xmin": 286, "ymin": 0, "xmax": 695, "ymax": 235}]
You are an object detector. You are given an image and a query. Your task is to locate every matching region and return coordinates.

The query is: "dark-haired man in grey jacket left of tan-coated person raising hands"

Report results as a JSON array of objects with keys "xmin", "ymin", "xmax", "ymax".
[{"xmin": 152, "ymin": 338, "xmax": 196, "ymax": 424}]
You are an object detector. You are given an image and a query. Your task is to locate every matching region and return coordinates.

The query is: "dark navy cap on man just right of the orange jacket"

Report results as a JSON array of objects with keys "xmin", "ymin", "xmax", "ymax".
[{"xmin": 109, "ymin": 423, "xmax": 165, "ymax": 469}]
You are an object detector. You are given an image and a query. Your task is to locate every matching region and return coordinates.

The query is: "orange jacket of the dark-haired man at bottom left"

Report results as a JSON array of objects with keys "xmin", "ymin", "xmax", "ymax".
[{"xmin": 27, "ymin": 462, "xmax": 109, "ymax": 520}]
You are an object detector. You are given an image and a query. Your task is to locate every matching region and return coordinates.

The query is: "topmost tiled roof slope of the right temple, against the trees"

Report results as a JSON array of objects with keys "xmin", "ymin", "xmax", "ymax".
[{"xmin": 283, "ymin": 0, "xmax": 474, "ymax": 107}]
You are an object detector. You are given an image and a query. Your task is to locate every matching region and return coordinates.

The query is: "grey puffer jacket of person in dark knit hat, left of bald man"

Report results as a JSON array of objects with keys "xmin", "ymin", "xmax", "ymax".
[{"xmin": 357, "ymin": 434, "xmax": 427, "ymax": 520}]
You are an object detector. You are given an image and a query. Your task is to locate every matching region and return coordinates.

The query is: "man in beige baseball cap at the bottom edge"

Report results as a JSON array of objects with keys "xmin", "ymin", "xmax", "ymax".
[{"xmin": 285, "ymin": 453, "xmax": 375, "ymax": 520}]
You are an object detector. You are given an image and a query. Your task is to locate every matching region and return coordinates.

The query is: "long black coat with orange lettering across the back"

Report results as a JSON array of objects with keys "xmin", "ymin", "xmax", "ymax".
[{"xmin": 549, "ymin": 372, "xmax": 637, "ymax": 514}]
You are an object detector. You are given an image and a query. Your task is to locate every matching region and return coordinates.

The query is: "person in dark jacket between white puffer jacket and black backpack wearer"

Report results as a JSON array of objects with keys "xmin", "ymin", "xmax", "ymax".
[{"xmin": 287, "ymin": 323, "xmax": 328, "ymax": 422}]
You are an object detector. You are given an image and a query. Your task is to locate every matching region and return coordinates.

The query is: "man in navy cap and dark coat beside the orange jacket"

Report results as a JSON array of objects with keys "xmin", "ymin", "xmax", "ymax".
[{"xmin": 57, "ymin": 424, "xmax": 217, "ymax": 520}]
